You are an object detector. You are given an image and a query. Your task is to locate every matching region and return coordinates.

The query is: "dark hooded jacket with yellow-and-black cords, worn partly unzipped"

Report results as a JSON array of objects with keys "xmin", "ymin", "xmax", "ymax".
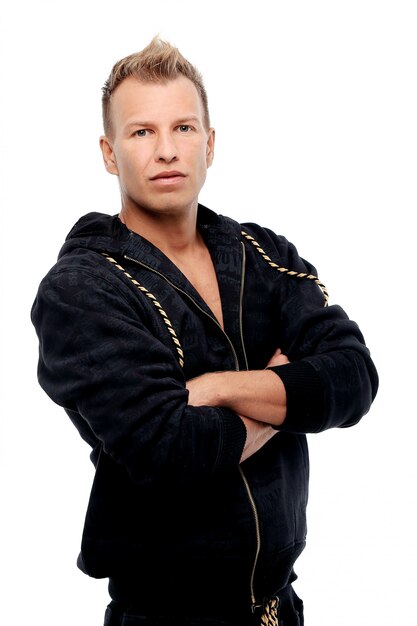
[{"xmin": 32, "ymin": 205, "xmax": 378, "ymax": 606}]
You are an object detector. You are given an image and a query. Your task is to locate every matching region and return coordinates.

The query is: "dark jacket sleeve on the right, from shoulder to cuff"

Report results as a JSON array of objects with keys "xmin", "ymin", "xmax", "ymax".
[{"xmin": 245, "ymin": 227, "xmax": 378, "ymax": 433}]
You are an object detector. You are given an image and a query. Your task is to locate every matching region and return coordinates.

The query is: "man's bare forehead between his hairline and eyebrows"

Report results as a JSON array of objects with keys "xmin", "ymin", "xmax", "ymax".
[{"xmin": 111, "ymin": 76, "xmax": 204, "ymax": 131}]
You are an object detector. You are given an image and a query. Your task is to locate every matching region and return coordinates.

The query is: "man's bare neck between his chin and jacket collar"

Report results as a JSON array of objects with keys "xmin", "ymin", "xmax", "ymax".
[{"xmin": 119, "ymin": 204, "xmax": 200, "ymax": 257}]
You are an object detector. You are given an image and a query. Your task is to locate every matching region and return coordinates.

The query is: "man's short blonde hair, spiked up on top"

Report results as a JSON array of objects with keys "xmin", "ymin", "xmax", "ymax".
[{"xmin": 102, "ymin": 37, "xmax": 210, "ymax": 135}]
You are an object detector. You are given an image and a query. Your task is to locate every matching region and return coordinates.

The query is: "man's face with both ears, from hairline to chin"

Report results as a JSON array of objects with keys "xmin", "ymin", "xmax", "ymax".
[{"xmin": 101, "ymin": 76, "xmax": 214, "ymax": 214}]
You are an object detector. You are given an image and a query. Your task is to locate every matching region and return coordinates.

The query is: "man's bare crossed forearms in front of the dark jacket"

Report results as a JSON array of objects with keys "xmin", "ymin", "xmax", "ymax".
[{"xmin": 186, "ymin": 349, "xmax": 289, "ymax": 462}]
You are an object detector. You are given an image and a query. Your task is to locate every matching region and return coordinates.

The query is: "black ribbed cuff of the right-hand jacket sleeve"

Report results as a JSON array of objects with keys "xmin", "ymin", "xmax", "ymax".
[{"xmin": 268, "ymin": 361, "xmax": 324, "ymax": 433}]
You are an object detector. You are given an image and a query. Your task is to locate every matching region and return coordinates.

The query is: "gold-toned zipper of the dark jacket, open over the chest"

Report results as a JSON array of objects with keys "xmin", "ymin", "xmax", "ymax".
[{"xmin": 123, "ymin": 249, "xmax": 261, "ymax": 612}]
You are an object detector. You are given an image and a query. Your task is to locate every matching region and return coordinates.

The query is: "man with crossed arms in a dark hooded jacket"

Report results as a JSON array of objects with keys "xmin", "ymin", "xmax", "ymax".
[{"xmin": 32, "ymin": 40, "xmax": 378, "ymax": 626}]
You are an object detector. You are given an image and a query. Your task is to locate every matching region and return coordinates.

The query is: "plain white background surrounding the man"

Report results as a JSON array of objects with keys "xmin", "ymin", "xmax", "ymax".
[{"xmin": 0, "ymin": 0, "xmax": 417, "ymax": 626}]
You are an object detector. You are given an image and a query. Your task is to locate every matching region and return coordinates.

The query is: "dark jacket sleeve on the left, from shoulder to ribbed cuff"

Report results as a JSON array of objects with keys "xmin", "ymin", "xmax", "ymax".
[{"xmin": 32, "ymin": 269, "xmax": 246, "ymax": 484}]
